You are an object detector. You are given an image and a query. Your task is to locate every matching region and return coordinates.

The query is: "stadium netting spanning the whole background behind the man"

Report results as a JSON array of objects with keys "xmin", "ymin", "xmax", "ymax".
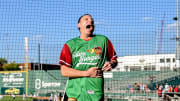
[{"xmin": 0, "ymin": 0, "xmax": 180, "ymax": 101}]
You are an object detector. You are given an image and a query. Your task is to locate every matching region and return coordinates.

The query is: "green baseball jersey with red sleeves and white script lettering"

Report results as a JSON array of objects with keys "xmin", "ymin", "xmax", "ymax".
[{"xmin": 60, "ymin": 35, "xmax": 116, "ymax": 101}]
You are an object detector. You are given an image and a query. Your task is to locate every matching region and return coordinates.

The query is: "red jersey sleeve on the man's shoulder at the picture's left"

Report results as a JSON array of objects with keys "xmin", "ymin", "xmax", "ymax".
[{"xmin": 59, "ymin": 44, "xmax": 72, "ymax": 67}]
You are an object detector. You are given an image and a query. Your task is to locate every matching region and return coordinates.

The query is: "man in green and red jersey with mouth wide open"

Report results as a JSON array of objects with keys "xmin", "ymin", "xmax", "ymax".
[{"xmin": 59, "ymin": 14, "xmax": 117, "ymax": 101}]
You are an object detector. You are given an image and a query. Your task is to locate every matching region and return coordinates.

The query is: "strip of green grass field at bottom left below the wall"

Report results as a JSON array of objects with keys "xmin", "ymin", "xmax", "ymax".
[{"xmin": 0, "ymin": 96, "xmax": 38, "ymax": 101}]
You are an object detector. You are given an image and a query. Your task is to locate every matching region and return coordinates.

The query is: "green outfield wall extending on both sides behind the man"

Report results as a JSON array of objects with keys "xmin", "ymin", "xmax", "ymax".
[{"xmin": 0, "ymin": 70, "xmax": 179, "ymax": 96}]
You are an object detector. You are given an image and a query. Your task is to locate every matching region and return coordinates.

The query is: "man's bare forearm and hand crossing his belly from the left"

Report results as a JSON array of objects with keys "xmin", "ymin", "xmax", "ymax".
[{"xmin": 61, "ymin": 65, "xmax": 101, "ymax": 78}]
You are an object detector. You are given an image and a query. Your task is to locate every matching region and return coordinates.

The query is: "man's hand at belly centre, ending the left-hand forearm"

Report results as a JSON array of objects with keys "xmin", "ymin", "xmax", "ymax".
[{"xmin": 87, "ymin": 67, "xmax": 102, "ymax": 78}]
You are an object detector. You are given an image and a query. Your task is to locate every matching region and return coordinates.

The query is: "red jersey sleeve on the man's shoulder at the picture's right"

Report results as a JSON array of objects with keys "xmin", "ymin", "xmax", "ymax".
[{"xmin": 107, "ymin": 40, "xmax": 117, "ymax": 60}]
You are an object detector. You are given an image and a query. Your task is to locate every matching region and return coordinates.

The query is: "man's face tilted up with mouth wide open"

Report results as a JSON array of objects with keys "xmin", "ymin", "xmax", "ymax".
[{"xmin": 78, "ymin": 15, "xmax": 94, "ymax": 34}]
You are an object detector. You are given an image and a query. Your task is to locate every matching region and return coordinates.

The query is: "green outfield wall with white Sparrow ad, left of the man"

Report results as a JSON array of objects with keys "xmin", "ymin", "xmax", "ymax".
[{"xmin": 0, "ymin": 70, "xmax": 67, "ymax": 95}]
